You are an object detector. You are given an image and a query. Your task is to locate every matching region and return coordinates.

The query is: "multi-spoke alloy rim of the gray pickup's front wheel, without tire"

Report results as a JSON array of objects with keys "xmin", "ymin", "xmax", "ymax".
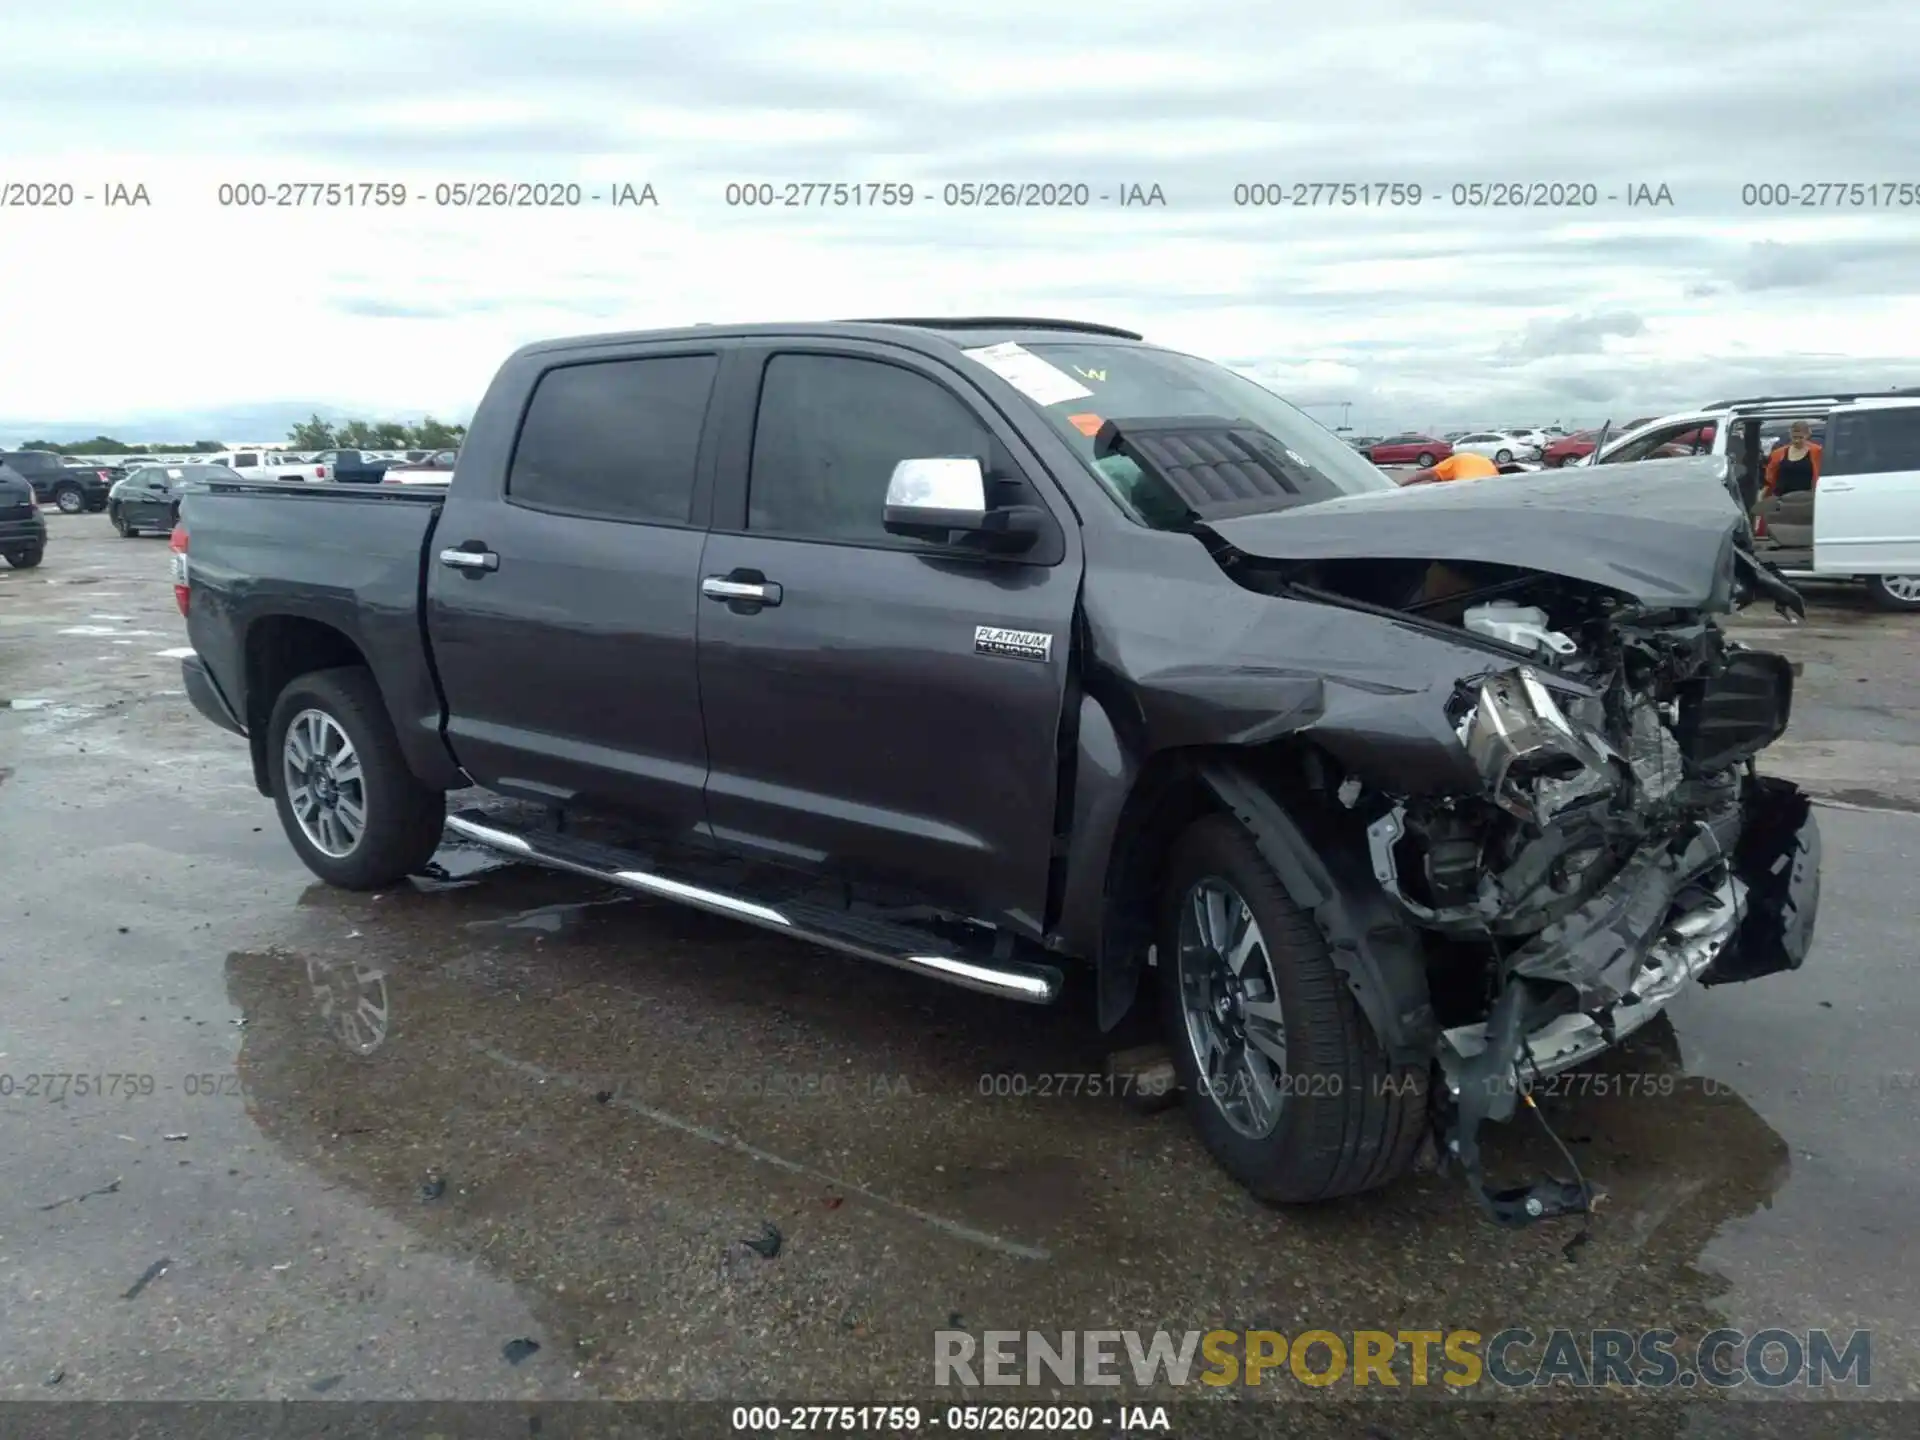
[{"xmin": 1173, "ymin": 877, "xmax": 1288, "ymax": 1140}]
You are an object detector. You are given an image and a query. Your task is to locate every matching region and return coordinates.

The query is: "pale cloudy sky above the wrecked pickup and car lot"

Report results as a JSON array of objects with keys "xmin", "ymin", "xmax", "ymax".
[{"xmin": 0, "ymin": 0, "xmax": 1920, "ymax": 442}]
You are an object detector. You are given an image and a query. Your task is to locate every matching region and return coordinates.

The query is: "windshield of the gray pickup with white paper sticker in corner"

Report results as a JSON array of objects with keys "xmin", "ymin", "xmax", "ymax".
[{"xmin": 990, "ymin": 342, "xmax": 1394, "ymax": 528}]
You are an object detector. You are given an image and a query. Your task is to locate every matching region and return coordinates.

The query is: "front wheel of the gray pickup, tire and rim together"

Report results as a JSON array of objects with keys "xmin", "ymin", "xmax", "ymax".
[{"xmin": 1158, "ymin": 816, "xmax": 1427, "ymax": 1204}]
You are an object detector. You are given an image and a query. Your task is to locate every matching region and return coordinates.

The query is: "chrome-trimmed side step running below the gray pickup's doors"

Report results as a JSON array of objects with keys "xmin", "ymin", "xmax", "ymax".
[{"xmin": 447, "ymin": 814, "xmax": 1062, "ymax": 1004}]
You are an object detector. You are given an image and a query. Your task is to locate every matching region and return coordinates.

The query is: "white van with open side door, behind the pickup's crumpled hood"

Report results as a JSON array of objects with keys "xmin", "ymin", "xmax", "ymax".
[{"xmin": 1588, "ymin": 390, "xmax": 1920, "ymax": 611}]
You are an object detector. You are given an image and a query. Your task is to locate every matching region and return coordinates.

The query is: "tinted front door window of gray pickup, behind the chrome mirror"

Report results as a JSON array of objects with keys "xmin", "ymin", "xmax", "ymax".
[{"xmin": 747, "ymin": 355, "xmax": 1010, "ymax": 545}]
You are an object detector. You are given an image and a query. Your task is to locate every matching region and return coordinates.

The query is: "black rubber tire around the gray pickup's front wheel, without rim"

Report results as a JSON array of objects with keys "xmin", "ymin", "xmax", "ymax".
[{"xmin": 1158, "ymin": 816, "xmax": 1428, "ymax": 1204}]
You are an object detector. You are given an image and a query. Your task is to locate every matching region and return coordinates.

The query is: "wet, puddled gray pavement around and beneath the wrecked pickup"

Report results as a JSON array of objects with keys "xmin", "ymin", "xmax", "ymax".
[{"xmin": 0, "ymin": 515, "xmax": 1920, "ymax": 1434}]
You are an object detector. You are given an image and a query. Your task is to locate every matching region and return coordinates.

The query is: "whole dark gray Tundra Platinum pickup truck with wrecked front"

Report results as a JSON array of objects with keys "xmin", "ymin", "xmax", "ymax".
[{"xmin": 173, "ymin": 319, "xmax": 1818, "ymax": 1223}]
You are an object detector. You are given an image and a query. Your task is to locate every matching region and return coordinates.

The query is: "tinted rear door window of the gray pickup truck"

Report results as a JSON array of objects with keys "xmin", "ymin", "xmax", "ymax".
[{"xmin": 507, "ymin": 355, "xmax": 720, "ymax": 524}]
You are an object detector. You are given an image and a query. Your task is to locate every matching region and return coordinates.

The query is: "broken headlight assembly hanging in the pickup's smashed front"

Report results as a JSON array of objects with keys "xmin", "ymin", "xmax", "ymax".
[{"xmin": 1453, "ymin": 666, "xmax": 1628, "ymax": 826}]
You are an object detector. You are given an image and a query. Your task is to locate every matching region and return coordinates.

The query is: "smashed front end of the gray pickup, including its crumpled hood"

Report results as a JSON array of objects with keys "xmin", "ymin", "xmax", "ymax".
[{"xmin": 1208, "ymin": 456, "xmax": 1820, "ymax": 1223}]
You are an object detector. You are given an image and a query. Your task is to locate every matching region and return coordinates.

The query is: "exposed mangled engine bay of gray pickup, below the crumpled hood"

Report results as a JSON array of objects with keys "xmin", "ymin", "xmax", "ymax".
[{"xmin": 1213, "ymin": 559, "xmax": 1818, "ymax": 1223}]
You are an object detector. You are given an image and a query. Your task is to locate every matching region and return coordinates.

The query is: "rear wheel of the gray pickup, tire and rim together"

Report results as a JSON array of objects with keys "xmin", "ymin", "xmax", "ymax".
[{"xmin": 267, "ymin": 666, "xmax": 447, "ymax": 891}]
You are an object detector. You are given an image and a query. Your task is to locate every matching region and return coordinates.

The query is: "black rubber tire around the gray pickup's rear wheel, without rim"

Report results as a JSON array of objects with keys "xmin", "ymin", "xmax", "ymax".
[{"xmin": 267, "ymin": 666, "xmax": 447, "ymax": 891}]
